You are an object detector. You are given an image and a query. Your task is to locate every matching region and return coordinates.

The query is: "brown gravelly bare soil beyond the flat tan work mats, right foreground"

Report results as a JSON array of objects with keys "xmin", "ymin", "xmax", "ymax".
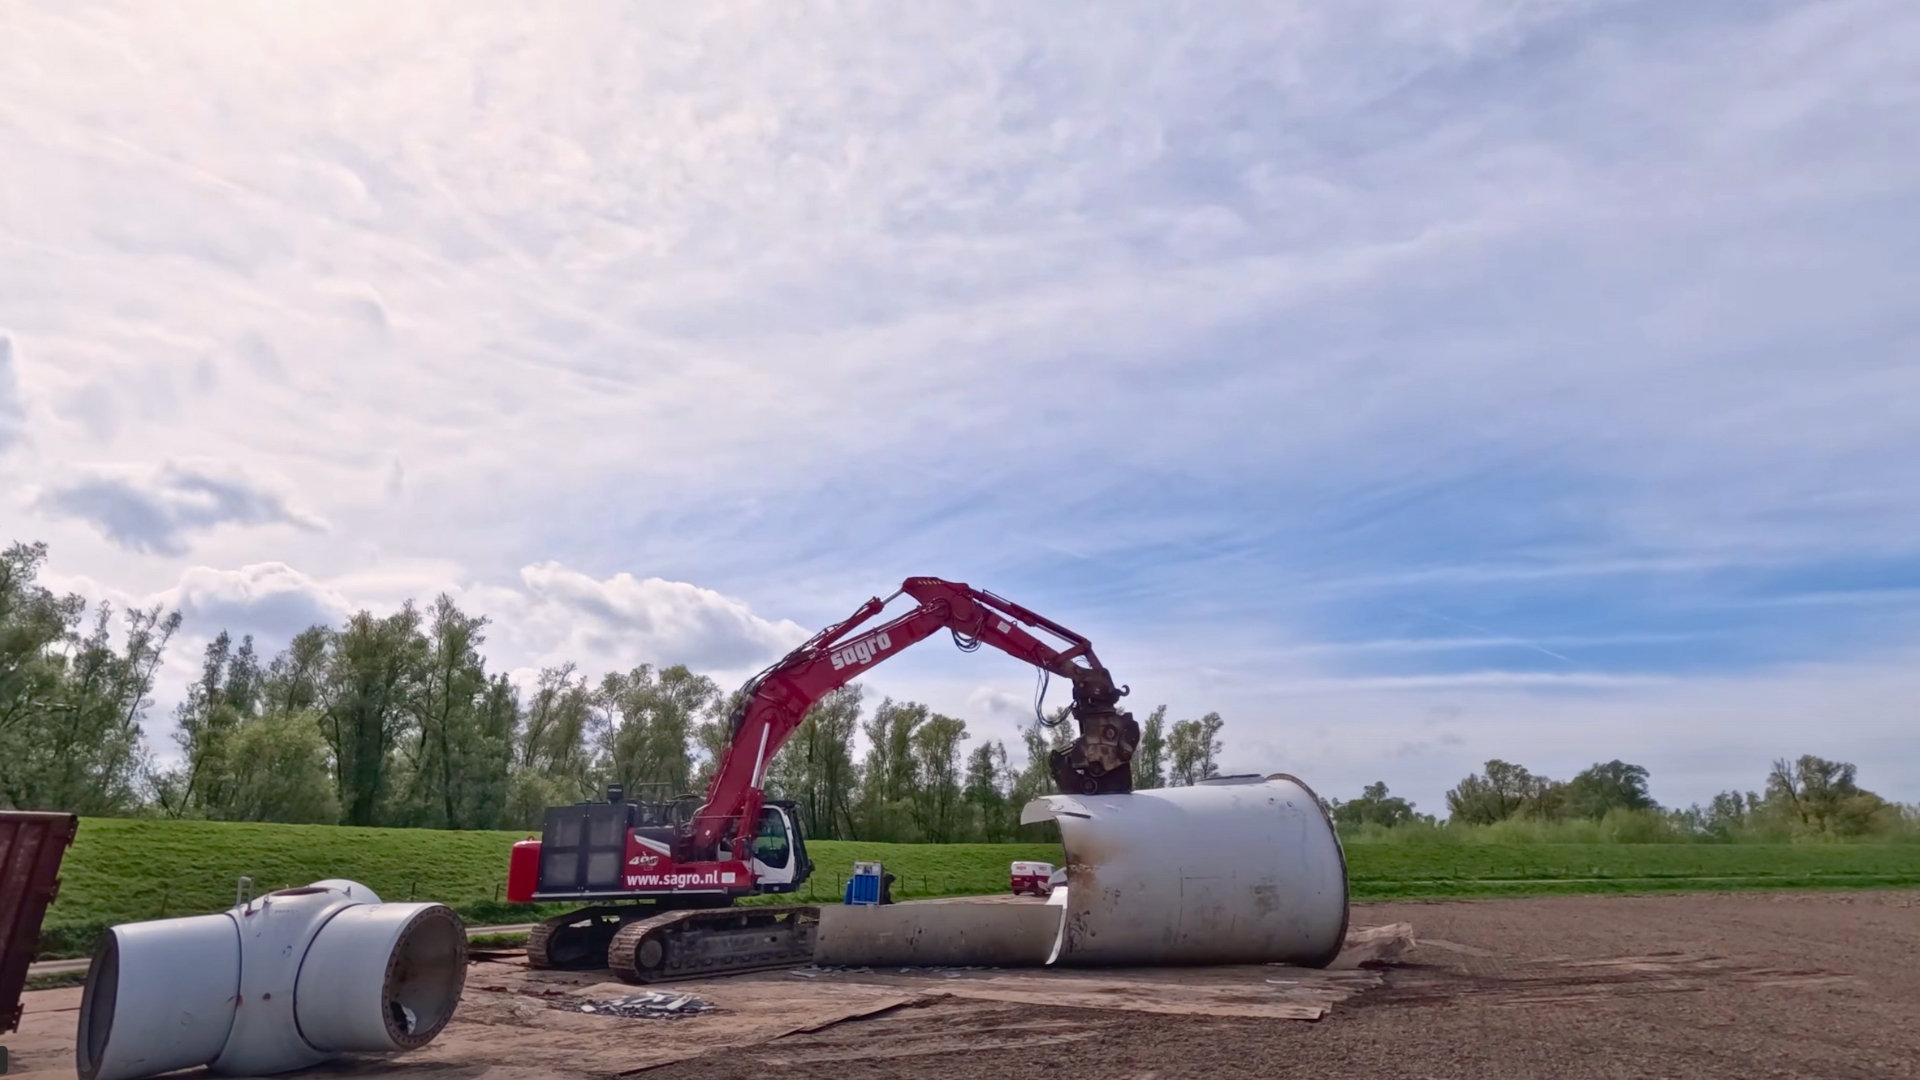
[{"xmin": 647, "ymin": 892, "xmax": 1920, "ymax": 1080}]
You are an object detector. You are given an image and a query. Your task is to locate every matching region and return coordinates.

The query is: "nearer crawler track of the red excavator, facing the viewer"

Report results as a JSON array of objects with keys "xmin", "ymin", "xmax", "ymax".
[{"xmin": 607, "ymin": 905, "xmax": 820, "ymax": 984}]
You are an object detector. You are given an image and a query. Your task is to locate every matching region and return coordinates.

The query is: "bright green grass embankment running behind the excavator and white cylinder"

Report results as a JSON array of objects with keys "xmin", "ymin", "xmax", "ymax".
[{"xmin": 40, "ymin": 819, "xmax": 1920, "ymax": 957}]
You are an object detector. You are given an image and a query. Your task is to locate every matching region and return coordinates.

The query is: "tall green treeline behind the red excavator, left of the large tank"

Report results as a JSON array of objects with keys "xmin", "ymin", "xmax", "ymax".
[{"xmin": 0, "ymin": 544, "xmax": 1223, "ymax": 842}]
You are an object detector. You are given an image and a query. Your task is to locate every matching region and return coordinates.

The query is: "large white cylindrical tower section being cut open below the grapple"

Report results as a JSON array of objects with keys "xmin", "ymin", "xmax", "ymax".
[{"xmin": 1021, "ymin": 773, "xmax": 1348, "ymax": 967}]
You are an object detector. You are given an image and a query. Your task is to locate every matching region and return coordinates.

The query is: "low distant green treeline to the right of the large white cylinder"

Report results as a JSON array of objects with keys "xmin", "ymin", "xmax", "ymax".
[{"xmin": 1329, "ymin": 755, "xmax": 1920, "ymax": 844}]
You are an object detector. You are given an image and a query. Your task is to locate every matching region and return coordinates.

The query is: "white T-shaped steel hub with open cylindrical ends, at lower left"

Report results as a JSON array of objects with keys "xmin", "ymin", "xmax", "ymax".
[{"xmin": 75, "ymin": 880, "xmax": 467, "ymax": 1080}]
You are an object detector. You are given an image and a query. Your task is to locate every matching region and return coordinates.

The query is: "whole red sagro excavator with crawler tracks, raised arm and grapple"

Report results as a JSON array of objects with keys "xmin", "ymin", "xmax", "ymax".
[{"xmin": 507, "ymin": 578, "xmax": 1140, "ymax": 982}]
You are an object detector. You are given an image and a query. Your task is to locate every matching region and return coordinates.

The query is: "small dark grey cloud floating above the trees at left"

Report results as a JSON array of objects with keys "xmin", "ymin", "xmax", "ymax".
[{"xmin": 33, "ymin": 461, "xmax": 324, "ymax": 555}]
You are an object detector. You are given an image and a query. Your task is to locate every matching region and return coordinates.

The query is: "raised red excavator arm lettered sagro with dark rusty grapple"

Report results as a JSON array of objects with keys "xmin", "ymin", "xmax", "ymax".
[{"xmin": 687, "ymin": 578, "xmax": 1140, "ymax": 857}]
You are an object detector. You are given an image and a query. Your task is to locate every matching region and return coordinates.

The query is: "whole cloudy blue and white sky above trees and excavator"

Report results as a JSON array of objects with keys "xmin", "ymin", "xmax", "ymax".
[{"xmin": 0, "ymin": 0, "xmax": 1920, "ymax": 813}]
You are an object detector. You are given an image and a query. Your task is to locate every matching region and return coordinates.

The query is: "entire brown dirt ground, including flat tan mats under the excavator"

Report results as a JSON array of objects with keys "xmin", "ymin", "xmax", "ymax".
[{"xmin": 4, "ymin": 892, "xmax": 1920, "ymax": 1080}]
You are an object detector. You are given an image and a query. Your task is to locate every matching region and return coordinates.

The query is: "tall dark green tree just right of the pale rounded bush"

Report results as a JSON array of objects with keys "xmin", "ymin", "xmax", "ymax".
[{"xmin": 319, "ymin": 601, "xmax": 426, "ymax": 824}]
